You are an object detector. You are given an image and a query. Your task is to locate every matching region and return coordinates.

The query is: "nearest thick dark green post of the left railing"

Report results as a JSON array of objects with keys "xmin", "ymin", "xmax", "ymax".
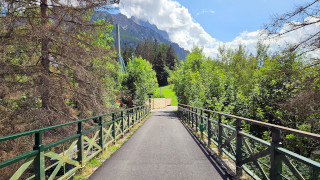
[{"xmin": 33, "ymin": 132, "xmax": 45, "ymax": 180}]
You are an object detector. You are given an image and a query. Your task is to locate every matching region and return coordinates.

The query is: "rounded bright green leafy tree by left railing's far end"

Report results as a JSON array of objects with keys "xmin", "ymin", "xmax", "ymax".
[{"xmin": 122, "ymin": 57, "xmax": 158, "ymax": 105}]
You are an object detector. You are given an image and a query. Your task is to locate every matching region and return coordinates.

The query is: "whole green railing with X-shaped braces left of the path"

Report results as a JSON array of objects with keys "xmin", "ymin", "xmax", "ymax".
[{"xmin": 0, "ymin": 106, "xmax": 150, "ymax": 179}]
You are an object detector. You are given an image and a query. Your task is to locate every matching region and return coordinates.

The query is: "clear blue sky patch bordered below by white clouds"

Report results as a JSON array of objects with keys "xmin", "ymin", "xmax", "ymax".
[{"xmin": 178, "ymin": 0, "xmax": 307, "ymax": 42}]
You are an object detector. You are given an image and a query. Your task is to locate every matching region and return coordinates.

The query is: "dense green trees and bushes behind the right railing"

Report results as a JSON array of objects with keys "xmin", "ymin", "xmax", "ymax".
[{"xmin": 170, "ymin": 43, "xmax": 320, "ymax": 160}]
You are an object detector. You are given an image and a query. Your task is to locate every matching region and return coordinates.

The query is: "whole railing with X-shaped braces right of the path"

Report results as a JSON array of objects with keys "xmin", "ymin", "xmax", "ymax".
[{"xmin": 178, "ymin": 104, "xmax": 320, "ymax": 180}]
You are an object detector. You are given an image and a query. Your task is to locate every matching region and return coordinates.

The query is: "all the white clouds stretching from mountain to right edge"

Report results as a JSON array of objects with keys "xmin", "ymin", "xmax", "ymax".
[{"xmin": 120, "ymin": 0, "xmax": 320, "ymax": 57}]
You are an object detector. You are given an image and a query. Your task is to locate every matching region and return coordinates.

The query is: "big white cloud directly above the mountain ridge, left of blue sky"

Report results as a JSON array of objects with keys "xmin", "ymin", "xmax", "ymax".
[{"xmin": 120, "ymin": 0, "xmax": 216, "ymax": 50}]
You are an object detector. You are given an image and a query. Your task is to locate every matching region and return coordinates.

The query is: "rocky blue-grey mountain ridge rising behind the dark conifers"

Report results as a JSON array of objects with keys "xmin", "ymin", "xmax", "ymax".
[{"xmin": 93, "ymin": 11, "xmax": 188, "ymax": 60}]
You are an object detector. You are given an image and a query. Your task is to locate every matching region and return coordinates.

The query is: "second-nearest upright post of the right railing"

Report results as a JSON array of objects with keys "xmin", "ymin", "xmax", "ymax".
[{"xmin": 236, "ymin": 119, "xmax": 242, "ymax": 177}]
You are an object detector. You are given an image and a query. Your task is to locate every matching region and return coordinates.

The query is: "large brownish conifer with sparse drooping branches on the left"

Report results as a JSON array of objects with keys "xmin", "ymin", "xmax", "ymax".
[{"xmin": 0, "ymin": 0, "xmax": 120, "ymax": 119}]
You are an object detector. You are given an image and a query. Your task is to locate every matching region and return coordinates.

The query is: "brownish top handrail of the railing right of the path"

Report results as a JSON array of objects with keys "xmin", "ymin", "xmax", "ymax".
[{"xmin": 178, "ymin": 104, "xmax": 320, "ymax": 140}]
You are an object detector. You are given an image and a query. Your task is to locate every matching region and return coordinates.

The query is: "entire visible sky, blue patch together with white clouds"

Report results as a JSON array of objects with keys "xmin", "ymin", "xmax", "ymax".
[{"xmin": 119, "ymin": 0, "xmax": 320, "ymax": 57}]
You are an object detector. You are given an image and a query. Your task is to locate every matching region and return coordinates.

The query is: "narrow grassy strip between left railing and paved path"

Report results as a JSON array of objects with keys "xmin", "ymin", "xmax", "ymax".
[{"xmin": 73, "ymin": 114, "xmax": 151, "ymax": 180}]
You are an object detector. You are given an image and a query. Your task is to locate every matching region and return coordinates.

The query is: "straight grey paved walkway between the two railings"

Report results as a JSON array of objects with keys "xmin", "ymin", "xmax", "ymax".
[{"xmin": 89, "ymin": 107, "xmax": 231, "ymax": 180}]
